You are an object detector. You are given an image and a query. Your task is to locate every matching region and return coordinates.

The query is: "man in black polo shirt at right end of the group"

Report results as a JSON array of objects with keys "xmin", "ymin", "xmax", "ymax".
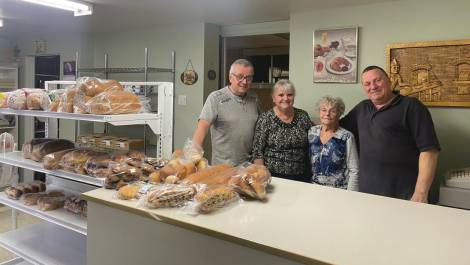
[{"xmin": 341, "ymin": 66, "xmax": 440, "ymax": 202}]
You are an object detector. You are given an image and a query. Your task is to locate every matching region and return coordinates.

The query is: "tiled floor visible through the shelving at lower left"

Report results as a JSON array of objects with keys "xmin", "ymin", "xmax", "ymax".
[{"xmin": 0, "ymin": 205, "xmax": 41, "ymax": 263}]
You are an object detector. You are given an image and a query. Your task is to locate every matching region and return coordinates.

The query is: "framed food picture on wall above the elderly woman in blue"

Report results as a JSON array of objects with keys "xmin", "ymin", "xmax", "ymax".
[{"xmin": 313, "ymin": 26, "xmax": 358, "ymax": 83}]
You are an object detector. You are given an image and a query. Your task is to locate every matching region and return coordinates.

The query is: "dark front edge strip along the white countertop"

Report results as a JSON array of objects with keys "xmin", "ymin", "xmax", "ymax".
[{"xmin": 82, "ymin": 194, "xmax": 331, "ymax": 265}]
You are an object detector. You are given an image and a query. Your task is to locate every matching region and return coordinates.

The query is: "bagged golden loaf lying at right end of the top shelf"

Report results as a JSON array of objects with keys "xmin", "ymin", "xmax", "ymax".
[{"xmin": 85, "ymin": 90, "xmax": 148, "ymax": 115}]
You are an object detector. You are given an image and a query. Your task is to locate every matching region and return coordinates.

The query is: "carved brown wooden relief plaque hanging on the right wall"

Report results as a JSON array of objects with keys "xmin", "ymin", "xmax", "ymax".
[{"xmin": 386, "ymin": 40, "xmax": 470, "ymax": 107}]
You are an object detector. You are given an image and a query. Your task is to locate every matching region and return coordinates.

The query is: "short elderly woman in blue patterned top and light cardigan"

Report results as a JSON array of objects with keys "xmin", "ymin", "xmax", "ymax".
[{"xmin": 308, "ymin": 96, "xmax": 359, "ymax": 191}]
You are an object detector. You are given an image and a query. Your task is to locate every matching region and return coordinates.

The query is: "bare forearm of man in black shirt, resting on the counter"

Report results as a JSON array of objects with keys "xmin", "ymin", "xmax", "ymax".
[{"xmin": 410, "ymin": 149, "xmax": 439, "ymax": 203}]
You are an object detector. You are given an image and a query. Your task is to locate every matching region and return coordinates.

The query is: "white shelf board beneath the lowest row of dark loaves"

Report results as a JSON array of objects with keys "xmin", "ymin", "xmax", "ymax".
[{"xmin": 0, "ymin": 192, "xmax": 87, "ymax": 235}]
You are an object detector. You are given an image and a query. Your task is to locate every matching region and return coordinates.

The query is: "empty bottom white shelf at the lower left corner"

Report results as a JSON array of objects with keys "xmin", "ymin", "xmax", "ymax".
[{"xmin": 0, "ymin": 222, "xmax": 86, "ymax": 265}]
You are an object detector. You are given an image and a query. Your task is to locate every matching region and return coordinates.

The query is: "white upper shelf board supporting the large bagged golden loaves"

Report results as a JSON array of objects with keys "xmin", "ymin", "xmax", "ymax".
[{"xmin": 0, "ymin": 109, "xmax": 160, "ymax": 134}]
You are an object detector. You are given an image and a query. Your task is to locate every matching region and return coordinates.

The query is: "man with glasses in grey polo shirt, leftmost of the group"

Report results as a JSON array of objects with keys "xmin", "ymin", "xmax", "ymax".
[{"xmin": 193, "ymin": 59, "xmax": 260, "ymax": 165}]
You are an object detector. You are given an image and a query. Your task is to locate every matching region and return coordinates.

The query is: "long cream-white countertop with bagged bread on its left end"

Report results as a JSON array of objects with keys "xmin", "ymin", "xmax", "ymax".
[{"xmin": 84, "ymin": 178, "xmax": 470, "ymax": 265}]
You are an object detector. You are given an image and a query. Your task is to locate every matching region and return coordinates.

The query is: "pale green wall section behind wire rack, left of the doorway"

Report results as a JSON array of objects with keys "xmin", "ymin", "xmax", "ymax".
[{"xmin": 94, "ymin": 23, "xmax": 205, "ymax": 148}]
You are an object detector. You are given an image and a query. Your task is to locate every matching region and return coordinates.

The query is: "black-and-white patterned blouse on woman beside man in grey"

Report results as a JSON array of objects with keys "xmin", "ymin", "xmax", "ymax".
[{"xmin": 253, "ymin": 108, "xmax": 312, "ymax": 176}]
